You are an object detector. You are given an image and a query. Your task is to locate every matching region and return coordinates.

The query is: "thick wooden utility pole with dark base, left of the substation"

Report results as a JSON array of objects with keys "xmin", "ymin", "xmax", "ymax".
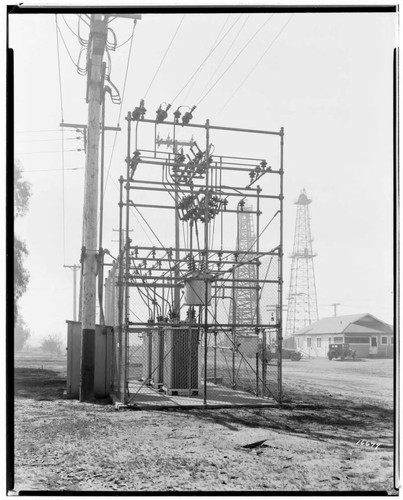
[{"xmin": 79, "ymin": 14, "xmax": 108, "ymax": 402}]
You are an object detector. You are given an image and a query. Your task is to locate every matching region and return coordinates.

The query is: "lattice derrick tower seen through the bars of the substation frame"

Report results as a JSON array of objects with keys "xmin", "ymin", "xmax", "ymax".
[{"xmin": 229, "ymin": 205, "xmax": 260, "ymax": 333}]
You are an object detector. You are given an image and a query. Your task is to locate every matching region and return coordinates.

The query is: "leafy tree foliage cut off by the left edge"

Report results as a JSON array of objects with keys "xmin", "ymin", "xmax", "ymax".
[{"xmin": 14, "ymin": 160, "xmax": 31, "ymax": 323}]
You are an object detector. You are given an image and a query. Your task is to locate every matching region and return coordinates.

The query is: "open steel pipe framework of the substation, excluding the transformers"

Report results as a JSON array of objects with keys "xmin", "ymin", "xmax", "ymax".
[{"xmin": 106, "ymin": 112, "xmax": 284, "ymax": 405}]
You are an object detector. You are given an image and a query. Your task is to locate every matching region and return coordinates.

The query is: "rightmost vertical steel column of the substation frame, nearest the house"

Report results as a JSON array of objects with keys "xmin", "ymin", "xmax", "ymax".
[{"xmin": 277, "ymin": 127, "xmax": 284, "ymax": 403}]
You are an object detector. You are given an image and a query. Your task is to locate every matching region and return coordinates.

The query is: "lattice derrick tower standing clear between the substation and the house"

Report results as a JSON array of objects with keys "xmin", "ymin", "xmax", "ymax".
[{"xmin": 286, "ymin": 189, "xmax": 319, "ymax": 336}]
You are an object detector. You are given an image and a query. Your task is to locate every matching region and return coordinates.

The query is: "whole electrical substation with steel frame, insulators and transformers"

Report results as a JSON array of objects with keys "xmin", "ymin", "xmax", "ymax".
[{"xmin": 104, "ymin": 107, "xmax": 284, "ymax": 408}]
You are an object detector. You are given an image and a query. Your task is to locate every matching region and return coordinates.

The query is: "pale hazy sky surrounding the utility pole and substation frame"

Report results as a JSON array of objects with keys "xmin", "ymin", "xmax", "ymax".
[{"xmin": 9, "ymin": 7, "xmax": 397, "ymax": 344}]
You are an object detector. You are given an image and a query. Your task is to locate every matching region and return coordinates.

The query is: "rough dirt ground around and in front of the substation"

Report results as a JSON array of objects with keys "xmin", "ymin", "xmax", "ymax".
[{"xmin": 14, "ymin": 357, "xmax": 397, "ymax": 494}]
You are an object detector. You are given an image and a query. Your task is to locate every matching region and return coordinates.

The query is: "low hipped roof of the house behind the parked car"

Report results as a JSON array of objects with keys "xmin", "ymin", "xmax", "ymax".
[{"xmin": 294, "ymin": 313, "xmax": 393, "ymax": 335}]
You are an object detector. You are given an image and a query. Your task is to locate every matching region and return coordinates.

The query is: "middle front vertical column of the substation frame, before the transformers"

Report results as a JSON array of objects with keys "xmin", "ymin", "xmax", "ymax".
[{"xmin": 203, "ymin": 120, "xmax": 210, "ymax": 404}]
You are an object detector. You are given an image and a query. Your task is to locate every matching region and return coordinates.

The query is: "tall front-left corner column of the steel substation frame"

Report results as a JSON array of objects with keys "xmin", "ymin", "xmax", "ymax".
[{"xmin": 123, "ymin": 112, "xmax": 131, "ymax": 403}]
